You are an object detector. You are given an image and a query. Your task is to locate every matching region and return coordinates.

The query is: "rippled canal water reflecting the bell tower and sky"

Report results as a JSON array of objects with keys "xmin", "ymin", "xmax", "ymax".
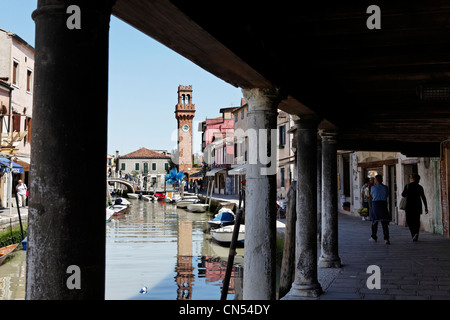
[{"xmin": 0, "ymin": 199, "xmax": 244, "ymax": 300}]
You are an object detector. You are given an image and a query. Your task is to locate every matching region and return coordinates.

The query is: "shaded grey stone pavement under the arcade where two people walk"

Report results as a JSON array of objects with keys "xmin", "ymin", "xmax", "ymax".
[{"xmin": 284, "ymin": 213, "xmax": 450, "ymax": 300}]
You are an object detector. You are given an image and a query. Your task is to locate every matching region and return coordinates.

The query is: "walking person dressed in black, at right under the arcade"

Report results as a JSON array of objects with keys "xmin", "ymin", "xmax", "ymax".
[{"xmin": 402, "ymin": 173, "xmax": 428, "ymax": 242}]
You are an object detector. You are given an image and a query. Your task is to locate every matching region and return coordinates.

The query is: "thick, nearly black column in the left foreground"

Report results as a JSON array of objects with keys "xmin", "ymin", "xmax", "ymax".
[{"xmin": 26, "ymin": 0, "xmax": 114, "ymax": 300}]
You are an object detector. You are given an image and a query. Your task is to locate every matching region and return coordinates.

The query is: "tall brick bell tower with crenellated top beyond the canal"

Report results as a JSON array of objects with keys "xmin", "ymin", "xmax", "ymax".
[{"xmin": 175, "ymin": 85, "xmax": 195, "ymax": 174}]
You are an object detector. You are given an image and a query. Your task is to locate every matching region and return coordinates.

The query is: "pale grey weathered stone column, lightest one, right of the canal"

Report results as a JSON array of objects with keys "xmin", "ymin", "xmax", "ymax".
[{"xmin": 242, "ymin": 89, "xmax": 281, "ymax": 300}]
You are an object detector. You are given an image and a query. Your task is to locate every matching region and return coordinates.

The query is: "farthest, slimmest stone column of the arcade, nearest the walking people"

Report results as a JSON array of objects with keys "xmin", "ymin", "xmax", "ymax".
[{"xmin": 319, "ymin": 130, "xmax": 341, "ymax": 268}]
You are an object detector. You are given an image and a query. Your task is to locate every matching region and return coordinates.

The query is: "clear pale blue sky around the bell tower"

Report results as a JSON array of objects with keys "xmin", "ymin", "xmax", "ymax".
[{"xmin": 0, "ymin": 0, "xmax": 242, "ymax": 155}]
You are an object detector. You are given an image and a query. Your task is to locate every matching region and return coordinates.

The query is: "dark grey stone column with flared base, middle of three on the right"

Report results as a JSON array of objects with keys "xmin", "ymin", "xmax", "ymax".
[{"xmin": 288, "ymin": 115, "xmax": 322, "ymax": 297}]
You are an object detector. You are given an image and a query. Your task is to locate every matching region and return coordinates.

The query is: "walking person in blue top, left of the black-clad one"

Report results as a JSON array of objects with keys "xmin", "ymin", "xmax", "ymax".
[{"xmin": 369, "ymin": 174, "xmax": 391, "ymax": 244}]
